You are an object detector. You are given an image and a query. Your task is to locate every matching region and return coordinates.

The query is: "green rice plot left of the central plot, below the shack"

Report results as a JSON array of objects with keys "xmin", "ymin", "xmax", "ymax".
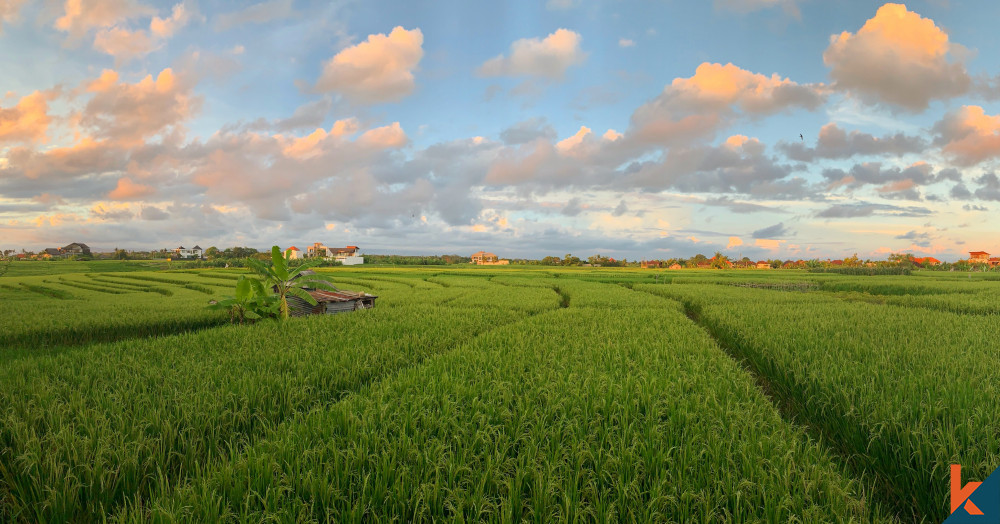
[{"xmin": 0, "ymin": 287, "xmax": 551, "ymax": 522}]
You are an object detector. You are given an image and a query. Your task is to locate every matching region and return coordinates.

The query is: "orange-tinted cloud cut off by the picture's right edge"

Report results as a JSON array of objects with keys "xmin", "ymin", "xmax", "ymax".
[{"xmin": 934, "ymin": 106, "xmax": 1000, "ymax": 166}]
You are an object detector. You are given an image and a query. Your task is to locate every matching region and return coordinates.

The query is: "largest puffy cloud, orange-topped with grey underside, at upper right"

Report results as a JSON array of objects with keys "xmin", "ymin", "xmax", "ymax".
[{"xmin": 823, "ymin": 4, "xmax": 971, "ymax": 111}]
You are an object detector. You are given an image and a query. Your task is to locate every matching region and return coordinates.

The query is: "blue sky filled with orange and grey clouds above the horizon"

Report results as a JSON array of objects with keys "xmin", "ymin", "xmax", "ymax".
[{"xmin": 0, "ymin": 0, "xmax": 1000, "ymax": 260}]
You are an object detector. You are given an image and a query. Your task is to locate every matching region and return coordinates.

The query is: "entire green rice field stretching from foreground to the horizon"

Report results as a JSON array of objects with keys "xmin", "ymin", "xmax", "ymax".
[{"xmin": 0, "ymin": 262, "xmax": 1000, "ymax": 523}]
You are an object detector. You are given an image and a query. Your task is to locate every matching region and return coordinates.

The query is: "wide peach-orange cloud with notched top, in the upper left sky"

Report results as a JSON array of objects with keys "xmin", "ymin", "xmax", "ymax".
[{"xmin": 80, "ymin": 68, "xmax": 201, "ymax": 143}]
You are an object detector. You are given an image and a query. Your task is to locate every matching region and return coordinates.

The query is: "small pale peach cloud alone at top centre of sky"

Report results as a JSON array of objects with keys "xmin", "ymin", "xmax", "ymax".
[{"xmin": 479, "ymin": 29, "xmax": 587, "ymax": 79}]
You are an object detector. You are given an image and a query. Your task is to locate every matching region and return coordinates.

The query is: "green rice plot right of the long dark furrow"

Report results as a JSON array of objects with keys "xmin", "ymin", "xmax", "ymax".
[{"xmin": 636, "ymin": 286, "xmax": 1000, "ymax": 520}]
